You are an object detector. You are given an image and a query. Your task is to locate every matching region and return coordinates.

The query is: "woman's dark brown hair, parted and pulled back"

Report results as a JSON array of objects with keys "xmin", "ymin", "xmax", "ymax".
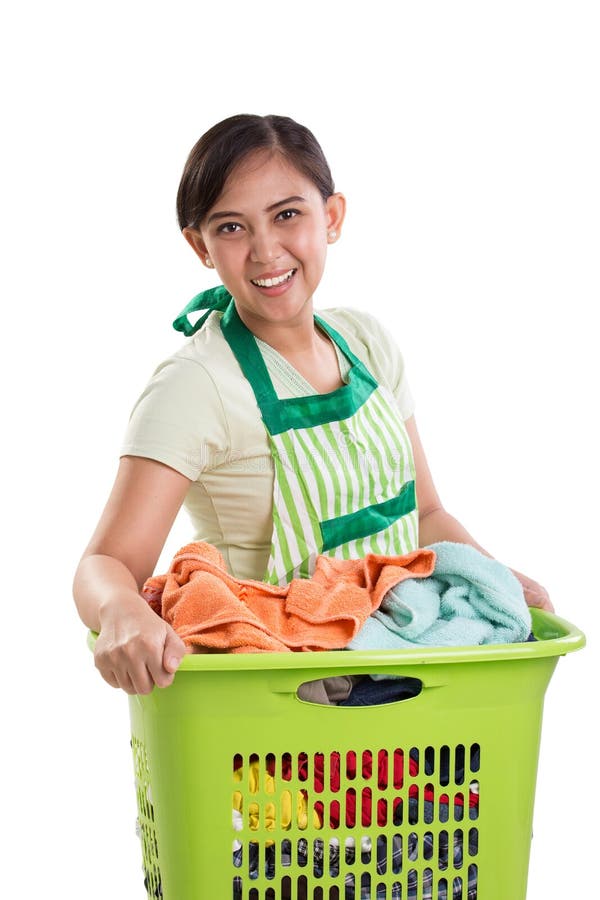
[{"xmin": 177, "ymin": 114, "xmax": 335, "ymax": 230}]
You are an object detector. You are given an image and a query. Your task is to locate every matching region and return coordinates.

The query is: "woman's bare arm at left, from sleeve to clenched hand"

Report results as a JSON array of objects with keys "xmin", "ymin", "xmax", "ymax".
[{"xmin": 73, "ymin": 456, "xmax": 190, "ymax": 694}]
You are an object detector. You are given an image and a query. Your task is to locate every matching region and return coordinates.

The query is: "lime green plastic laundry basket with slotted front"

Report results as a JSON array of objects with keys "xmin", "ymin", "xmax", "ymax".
[{"xmin": 96, "ymin": 610, "xmax": 585, "ymax": 900}]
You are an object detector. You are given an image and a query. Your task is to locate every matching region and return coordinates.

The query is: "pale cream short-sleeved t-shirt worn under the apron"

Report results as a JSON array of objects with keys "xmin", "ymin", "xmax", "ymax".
[{"xmin": 121, "ymin": 309, "xmax": 414, "ymax": 579}]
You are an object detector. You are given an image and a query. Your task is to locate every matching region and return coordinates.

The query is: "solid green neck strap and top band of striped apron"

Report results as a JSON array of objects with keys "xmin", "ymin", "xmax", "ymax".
[{"xmin": 221, "ymin": 302, "xmax": 378, "ymax": 435}]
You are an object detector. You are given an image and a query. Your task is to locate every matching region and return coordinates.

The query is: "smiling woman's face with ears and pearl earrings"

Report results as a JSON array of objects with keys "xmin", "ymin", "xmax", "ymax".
[{"xmin": 184, "ymin": 151, "xmax": 345, "ymax": 331}]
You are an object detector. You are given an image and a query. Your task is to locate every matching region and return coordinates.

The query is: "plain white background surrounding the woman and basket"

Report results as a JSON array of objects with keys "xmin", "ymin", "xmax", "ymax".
[{"xmin": 0, "ymin": 0, "xmax": 600, "ymax": 900}]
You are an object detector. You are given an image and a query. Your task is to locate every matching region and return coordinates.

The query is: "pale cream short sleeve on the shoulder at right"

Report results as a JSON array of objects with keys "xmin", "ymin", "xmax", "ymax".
[{"xmin": 323, "ymin": 309, "xmax": 415, "ymax": 421}]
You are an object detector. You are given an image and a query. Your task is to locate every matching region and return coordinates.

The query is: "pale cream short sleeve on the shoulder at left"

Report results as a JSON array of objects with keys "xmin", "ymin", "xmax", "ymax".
[{"xmin": 120, "ymin": 356, "xmax": 229, "ymax": 481}]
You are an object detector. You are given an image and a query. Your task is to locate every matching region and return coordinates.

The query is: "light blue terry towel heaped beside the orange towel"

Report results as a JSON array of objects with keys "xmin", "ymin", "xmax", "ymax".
[{"xmin": 348, "ymin": 541, "xmax": 531, "ymax": 650}]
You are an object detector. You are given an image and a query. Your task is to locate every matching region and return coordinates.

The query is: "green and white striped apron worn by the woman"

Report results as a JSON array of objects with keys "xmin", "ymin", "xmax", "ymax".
[{"xmin": 221, "ymin": 301, "xmax": 418, "ymax": 585}]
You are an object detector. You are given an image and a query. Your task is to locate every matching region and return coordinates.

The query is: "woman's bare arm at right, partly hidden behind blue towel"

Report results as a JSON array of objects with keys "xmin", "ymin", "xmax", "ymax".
[{"xmin": 405, "ymin": 416, "xmax": 554, "ymax": 612}]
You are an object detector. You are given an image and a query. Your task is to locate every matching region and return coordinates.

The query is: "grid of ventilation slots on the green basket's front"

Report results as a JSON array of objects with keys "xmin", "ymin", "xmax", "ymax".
[{"xmin": 232, "ymin": 744, "xmax": 480, "ymax": 900}]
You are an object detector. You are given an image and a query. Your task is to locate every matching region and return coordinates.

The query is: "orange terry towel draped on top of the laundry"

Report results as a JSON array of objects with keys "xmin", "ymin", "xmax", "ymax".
[{"xmin": 142, "ymin": 542, "xmax": 435, "ymax": 653}]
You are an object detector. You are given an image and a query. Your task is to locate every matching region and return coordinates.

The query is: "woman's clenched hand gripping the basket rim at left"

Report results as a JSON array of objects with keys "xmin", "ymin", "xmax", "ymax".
[{"xmin": 94, "ymin": 592, "xmax": 186, "ymax": 694}]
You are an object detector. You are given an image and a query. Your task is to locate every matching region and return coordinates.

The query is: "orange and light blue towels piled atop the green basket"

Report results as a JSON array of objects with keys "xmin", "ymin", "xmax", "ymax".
[{"xmin": 143, "ymin": 541, "xmax": 531, "ymax": 653}]
